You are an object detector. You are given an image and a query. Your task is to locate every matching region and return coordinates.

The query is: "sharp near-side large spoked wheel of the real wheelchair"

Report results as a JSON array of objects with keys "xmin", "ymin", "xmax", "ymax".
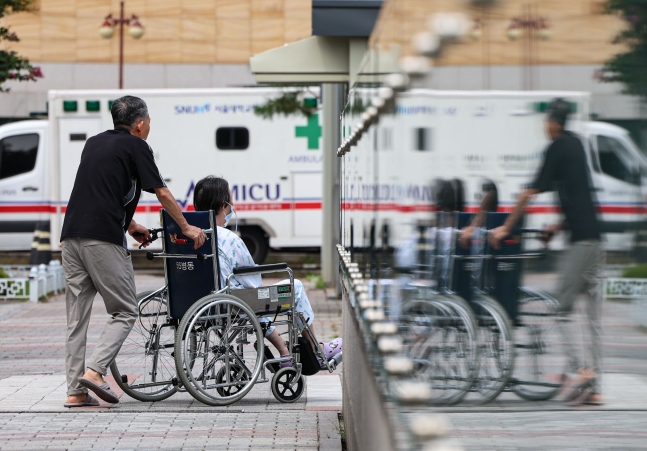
[{"xmin": 175, "ymin": 294, "xmax": 264, "ymax": 406}]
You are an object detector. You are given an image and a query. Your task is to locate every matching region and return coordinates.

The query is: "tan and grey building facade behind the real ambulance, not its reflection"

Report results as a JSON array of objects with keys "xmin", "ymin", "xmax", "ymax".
[{"xmin": 0, "ymin": 0, "xmax": 312, "ymax": 118}]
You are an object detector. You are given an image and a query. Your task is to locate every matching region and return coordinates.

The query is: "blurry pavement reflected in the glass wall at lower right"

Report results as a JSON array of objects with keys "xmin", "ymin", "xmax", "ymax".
[{"xmin": 405, "ymin": 274, "xmax": 647, "ymax": 451}]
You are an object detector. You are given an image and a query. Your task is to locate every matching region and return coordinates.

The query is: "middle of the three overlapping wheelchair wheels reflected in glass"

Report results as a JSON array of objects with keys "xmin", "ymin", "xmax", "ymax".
[{"xmin": 472, "ymin": 296, "xmax": 514, "ymax": 403}]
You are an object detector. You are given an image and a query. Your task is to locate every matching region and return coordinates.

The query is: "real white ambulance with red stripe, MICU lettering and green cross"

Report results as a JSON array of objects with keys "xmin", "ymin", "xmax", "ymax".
[{"xmin": 0, "ymin": 88, "xmax": 322, "ymax": 262}]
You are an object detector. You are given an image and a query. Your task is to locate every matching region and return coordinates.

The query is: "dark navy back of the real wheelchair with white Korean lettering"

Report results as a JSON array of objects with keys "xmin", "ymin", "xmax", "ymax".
[{"xmin": 160, "ymin": 210, "xmax": 221, "ymax": 321}]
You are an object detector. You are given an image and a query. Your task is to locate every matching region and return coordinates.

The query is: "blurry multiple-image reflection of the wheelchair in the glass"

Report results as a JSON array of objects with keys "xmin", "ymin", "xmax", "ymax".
[{"xmin": 398, "ymin": 213, "xmax": 566, "ymax": 404}]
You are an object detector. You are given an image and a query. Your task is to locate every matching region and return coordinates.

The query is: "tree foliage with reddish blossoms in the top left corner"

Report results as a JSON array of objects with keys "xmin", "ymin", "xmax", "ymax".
[{"xmin": 0, "ymin": 0, "xmax": 43, "ymax": 92}]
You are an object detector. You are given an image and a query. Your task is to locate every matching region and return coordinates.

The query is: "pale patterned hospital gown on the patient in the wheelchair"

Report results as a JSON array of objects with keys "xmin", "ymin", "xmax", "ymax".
[{"xmin": 218, "ymin": 227, "xmax": 315, "ymax": 336}]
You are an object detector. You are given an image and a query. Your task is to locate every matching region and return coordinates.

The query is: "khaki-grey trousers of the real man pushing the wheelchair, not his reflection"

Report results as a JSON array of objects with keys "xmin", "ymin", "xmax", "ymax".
[{"xmin": 62, "ymin": 238, "xmax": 137, "ymax": 395}]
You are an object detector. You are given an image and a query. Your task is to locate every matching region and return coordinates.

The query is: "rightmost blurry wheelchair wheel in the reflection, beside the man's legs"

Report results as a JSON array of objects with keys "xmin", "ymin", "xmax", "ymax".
[{"xmin": 512, "ymin": 288, "xmax": 568, "ymax": 401}]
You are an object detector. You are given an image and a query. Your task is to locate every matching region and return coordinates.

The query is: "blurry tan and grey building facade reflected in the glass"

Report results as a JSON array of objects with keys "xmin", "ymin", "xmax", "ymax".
[{"xmin": 369, "ymin": 0, "xmax": 647, "ymax": 144}]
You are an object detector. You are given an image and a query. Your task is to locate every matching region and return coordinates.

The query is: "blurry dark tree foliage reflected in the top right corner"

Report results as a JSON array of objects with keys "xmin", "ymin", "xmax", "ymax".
[{"xmin": 601, "ymin": 0, "xmax": 647, "ymax": 100}]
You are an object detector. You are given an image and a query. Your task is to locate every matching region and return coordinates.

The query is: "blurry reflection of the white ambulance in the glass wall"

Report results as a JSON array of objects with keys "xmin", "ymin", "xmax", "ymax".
[{"xmin": 342, "ymin": 89, "xmax": 647, "ymax": 250}]
